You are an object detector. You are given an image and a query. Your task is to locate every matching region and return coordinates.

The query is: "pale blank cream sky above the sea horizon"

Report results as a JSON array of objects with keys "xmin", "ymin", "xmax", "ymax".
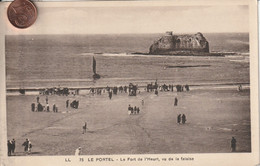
[{"xmin": 7, "ymin": 2, "xmax": 249, "ymax": 34}]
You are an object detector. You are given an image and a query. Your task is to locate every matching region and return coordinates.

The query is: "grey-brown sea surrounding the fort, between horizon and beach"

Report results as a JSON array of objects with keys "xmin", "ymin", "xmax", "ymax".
[{"xmin": 5, "ymin": 33, "xmax": 249, "ymax": 88}]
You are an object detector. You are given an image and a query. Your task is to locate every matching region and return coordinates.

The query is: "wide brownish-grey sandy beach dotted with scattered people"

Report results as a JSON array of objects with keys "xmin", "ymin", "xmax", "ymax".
[{"xmin": 7, "ymin": 88, "xmax": 251, "ymax": 155}]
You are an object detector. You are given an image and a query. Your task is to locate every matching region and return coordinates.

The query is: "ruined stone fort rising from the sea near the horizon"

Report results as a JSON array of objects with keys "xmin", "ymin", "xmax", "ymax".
[{"xmin": 149, "ymin": 32, "xmax": 209, "ymax": 55}]
